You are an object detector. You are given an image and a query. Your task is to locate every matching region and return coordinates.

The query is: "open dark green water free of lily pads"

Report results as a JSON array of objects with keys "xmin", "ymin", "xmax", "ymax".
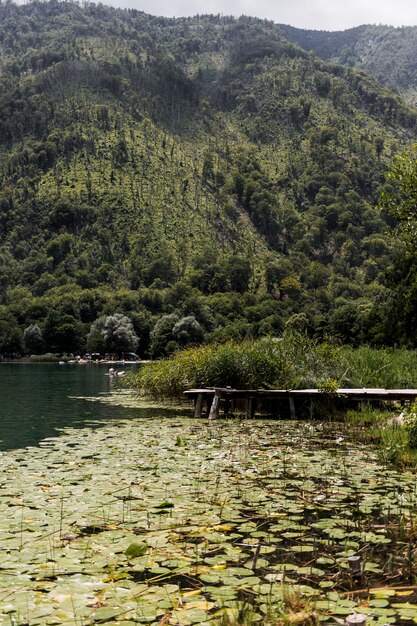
[{"xmin": 0, "ymin": 363, "xmax": 174, "ymax": 450}]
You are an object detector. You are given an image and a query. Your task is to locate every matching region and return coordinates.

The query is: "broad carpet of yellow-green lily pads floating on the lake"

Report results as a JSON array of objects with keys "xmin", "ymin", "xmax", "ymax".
[{"xmin": 0, "ymin": 418, "xmax": 417, "ymax": 626}]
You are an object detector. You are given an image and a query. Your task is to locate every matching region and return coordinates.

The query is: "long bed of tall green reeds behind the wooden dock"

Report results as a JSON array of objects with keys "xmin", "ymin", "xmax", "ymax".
[{"xmin": 128, "ymin": 332, "xmax": 417, "ymax": 399}]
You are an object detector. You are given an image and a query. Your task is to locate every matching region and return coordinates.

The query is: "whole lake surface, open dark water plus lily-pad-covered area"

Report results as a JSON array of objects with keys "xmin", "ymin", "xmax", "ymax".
[{"xmin": 0, "ymin": 363, "xmax": 417, "ymax": 626}]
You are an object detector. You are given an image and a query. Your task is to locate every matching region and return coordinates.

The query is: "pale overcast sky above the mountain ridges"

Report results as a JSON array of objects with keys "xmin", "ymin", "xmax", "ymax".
[{"xmin": 103, "ymin": 0, "xmax": 417, "ymax": 30}]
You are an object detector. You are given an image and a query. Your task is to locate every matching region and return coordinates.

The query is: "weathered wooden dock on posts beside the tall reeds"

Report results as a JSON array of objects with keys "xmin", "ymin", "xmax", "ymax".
[{"xmin": 184, "ymin": 387, "xmax": 417, "ymax": 419}]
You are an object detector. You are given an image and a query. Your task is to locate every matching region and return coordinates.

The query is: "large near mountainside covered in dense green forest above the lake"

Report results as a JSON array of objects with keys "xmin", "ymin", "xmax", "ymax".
[{"xmin": 0, "ymin": 0, "xmax": 417, "ymax": 357}]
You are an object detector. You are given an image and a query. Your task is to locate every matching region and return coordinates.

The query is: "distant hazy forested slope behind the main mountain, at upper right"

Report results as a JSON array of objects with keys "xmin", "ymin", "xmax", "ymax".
[{"xmin": 281, "ymin": 25, "xmax": 417, "ymax": 104}]
